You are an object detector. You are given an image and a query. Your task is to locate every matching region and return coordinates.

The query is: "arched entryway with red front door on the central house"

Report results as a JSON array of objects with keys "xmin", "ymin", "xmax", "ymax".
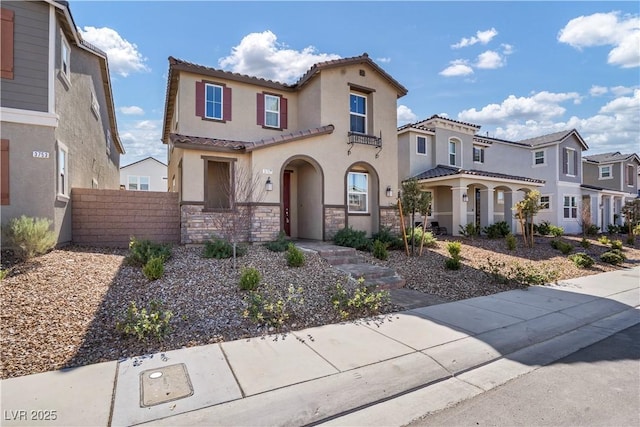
[{"xmin": 280, "ymin": 156, "xmax": 324, "ymax": 240}]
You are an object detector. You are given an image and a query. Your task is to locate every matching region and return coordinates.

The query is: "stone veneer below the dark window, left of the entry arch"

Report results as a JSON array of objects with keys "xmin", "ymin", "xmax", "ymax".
[{"xmin": 180, "ymin": 204, "xmax": 280, "ymax": 244}]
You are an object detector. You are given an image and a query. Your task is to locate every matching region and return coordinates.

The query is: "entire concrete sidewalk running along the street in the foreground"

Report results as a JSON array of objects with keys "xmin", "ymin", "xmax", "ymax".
[{"xmin": 0, "ymin": 267, "xmax": 640, "ymax": 426}]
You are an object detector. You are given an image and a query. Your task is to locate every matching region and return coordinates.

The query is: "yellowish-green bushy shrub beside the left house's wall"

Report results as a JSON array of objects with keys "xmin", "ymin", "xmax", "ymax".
[{"xmin": 2, "ymin": 215, "xmax": 56, "ymax": 260}]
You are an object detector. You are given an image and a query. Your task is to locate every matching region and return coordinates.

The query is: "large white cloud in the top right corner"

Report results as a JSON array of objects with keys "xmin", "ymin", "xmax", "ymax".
[{"xmin": 558, "ymin": 12, "xmax": 640, "ymax": 68}]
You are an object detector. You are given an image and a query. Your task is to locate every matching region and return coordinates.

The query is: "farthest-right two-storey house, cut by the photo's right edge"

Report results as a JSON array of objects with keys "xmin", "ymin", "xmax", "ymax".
[{"xmin": 582, "ymin": 152, "xmax": 640, "ymax": 231}]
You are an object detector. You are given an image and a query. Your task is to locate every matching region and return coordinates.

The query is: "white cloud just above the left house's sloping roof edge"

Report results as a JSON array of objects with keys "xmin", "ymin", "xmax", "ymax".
[{"xmin": 78, "ymin": 27, "xmax": 149, "ymax": 77}]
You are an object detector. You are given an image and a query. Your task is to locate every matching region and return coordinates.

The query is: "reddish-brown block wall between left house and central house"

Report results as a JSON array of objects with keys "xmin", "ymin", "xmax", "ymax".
[{"xmin": 71, "ymin": 188, "xmax": 180, "ymax": 248}]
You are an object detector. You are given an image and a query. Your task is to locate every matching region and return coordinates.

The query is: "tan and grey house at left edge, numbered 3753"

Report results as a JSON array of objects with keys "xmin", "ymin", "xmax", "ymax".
[{"xmin": 0, "ymin": 0, "xmax": 124, "ymax": 244}]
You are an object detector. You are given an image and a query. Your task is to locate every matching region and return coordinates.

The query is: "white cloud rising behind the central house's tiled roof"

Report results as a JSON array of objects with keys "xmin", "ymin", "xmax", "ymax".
[{"xmin": 218, "ymin": 30, "xmax": 340, "ymax": 83}]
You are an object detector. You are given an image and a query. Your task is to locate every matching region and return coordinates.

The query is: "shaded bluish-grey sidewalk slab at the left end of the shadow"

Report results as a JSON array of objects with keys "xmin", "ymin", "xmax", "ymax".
[{"xmin": 410, "ymin": 302, "xmax": 522, "ymax": 334}]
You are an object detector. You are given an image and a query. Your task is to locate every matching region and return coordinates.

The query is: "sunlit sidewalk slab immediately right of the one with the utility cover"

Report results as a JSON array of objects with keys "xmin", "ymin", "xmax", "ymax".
[{"xmin": 220, "ymin": 334, "xmax": 338, "ymax": 396}]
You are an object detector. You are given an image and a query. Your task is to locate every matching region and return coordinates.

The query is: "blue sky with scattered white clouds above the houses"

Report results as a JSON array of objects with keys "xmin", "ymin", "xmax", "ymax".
[{"xmin": 70, "ymin": 0, "xmax": 640, "ymax": 165}]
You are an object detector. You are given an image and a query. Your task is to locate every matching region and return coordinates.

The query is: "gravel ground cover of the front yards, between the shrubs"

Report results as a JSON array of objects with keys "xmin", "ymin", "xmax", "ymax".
[{"xmin": 0, "ymin": 236, "xmax": 640, "ymax": 378}]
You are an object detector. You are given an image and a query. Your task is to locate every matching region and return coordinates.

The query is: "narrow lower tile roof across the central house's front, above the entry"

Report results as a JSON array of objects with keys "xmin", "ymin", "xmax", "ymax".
[{"xmin": 169, "ymin": 125, "xmax": 334, "ymax": 153}]
